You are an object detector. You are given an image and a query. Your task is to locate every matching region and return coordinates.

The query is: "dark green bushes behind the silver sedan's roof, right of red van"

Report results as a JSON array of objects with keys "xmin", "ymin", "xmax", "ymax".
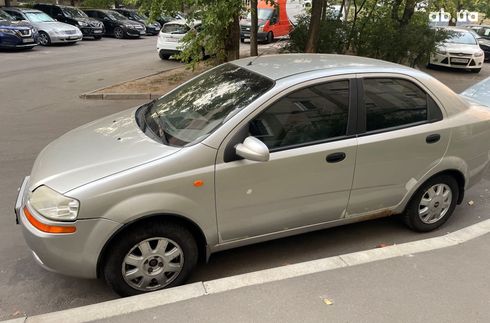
[{"xmin": 288, "ymin": 1, "xmax": 448, "ymax": 66}]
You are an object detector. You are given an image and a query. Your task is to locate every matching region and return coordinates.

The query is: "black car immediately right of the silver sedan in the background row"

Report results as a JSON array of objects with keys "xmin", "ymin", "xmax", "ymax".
[{"xmin": 34, "ymin": 3, "xmax": 105, "ymax": 39}]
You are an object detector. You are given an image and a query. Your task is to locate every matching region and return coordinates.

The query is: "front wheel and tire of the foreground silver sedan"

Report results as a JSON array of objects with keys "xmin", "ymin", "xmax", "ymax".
[{"xmin": 103, "ymin": 221, "xmax": 198, "ymax": 297}]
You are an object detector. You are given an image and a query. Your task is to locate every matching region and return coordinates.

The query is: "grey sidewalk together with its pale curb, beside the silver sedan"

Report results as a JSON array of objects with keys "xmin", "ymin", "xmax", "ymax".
[{"xmin": 15, "ymin": 220, "xmax": 490, "ymax": 323}]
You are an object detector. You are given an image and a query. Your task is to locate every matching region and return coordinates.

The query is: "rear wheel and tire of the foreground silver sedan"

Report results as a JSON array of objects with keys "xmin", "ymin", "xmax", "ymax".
[{"xmin": 403, "ymin": 175, "xmax": 459, "ymax": 232}]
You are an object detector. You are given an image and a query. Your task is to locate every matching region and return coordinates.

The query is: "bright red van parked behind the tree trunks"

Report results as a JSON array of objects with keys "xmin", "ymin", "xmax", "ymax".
[{"xmin": 240, "ymin": 0, "xmax": 305, "ymax": 43}]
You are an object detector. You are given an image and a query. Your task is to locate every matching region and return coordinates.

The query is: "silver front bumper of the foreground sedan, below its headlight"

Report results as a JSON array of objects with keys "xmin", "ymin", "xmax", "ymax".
[{"xmin": 15, "ymin": 178, "xmax": 121, "ymax": 278}]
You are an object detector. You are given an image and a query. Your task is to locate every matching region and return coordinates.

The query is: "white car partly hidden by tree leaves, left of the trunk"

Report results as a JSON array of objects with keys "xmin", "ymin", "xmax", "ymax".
[{"xmin": 157, "ymin": 19, "xmax": 201, "ymax": 59}]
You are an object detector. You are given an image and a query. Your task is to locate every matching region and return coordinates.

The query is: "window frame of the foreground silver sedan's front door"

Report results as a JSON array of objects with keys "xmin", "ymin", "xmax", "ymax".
[{"xmin": 223, "ymin": 74, "xmax": 359, "ymax": 163}]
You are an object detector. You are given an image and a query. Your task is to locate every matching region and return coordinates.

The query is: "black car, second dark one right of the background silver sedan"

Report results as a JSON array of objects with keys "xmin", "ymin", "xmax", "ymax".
[{"xmin": 83, "ymin": 9, "xmax": 146, "ymax": 39}]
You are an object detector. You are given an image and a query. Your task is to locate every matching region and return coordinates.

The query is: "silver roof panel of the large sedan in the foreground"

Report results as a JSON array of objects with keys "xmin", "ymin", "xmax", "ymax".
[{"xmin": 232, "ymin": 54, "xmax": 416, "ymax": 80}]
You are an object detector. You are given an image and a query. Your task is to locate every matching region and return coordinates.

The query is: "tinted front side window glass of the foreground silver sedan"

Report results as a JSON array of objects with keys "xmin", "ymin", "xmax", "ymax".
[{"xmin": 249, "ymin": 80, "xmax": 349, "ymax": 149}]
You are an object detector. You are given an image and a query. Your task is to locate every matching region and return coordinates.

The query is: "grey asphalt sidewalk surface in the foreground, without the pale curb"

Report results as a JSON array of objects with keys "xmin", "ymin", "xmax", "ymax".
[{"xmin": 102, "ymin": 234, "xmax": 490, "ymax": 323}]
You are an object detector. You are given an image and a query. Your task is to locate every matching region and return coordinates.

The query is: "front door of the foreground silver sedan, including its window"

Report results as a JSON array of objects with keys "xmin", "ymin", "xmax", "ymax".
[{"xmin": 216, "ymin": 79, "xmax": 357, "ymax": 242}]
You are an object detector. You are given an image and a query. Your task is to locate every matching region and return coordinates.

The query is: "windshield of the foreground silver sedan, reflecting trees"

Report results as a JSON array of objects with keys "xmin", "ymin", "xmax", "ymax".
[{"xmin": 139, "ymin": 64, "xmax": 274, "ymax": 147}]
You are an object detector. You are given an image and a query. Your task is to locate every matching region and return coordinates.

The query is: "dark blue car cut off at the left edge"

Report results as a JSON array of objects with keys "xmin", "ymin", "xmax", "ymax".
[{"xmin": 0, "ymin": 10, "xmax": 38, "ymax": 49}]
